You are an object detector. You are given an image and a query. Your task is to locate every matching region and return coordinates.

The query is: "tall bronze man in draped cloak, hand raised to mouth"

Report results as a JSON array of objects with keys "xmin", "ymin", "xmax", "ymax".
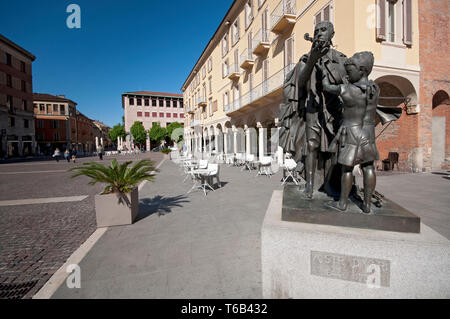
[{"xmin": 280, "ymin": 21, "xmax": 346, "ymax": 198}]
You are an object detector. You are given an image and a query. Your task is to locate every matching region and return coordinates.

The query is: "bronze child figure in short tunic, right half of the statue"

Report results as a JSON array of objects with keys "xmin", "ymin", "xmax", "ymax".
[{"xmin": 322, "ymin": 52, "xmax": 380, "ymax": 214}]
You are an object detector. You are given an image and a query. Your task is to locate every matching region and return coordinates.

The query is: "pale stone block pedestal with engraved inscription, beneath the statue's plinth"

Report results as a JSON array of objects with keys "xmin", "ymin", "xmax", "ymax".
[{"xmin": 261, "ymin": 191, "xmax": 450, "ymax": 298}]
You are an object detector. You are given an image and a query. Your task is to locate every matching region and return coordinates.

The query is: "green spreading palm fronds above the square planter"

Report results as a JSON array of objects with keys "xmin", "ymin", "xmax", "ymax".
[{"xmin": 69, "ymin": 159, "xmax": 157, "ymax": 193}]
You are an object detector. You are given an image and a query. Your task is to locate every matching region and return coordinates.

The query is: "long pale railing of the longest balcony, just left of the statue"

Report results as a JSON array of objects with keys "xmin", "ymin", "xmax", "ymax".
[{"xmin": 225, "ymin": 63, "xmax": 295, "ymax": 113}]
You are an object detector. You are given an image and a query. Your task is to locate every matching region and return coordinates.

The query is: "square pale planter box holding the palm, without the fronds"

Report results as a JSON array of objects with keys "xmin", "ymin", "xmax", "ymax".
[{"xmin": 95, "ymin": 187, "xmax": 139, "ymax": 228}]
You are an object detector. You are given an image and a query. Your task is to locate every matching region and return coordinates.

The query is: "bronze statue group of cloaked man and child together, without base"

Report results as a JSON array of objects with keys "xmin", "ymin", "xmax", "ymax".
[{"xmin": 280, "ymin": 22, "xmax": 401, "ymax": 214}]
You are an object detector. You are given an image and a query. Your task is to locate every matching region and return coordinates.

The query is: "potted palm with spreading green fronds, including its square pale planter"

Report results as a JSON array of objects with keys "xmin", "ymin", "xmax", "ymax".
[{"xmin": 70, "ymin": 159, "xmax": 156, "ymax": 227}]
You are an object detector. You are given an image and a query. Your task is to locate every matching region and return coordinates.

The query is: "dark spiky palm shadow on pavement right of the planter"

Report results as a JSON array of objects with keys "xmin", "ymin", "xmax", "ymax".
[{"xmin": 136, "ymin": 195, "xmax": 189, "ymax": 222}]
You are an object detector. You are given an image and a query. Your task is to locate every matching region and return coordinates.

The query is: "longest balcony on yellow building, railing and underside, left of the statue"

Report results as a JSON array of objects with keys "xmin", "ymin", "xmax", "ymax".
[{"xmin": 224, "ymin": 63, "xmax": 295, "ymax": 116}]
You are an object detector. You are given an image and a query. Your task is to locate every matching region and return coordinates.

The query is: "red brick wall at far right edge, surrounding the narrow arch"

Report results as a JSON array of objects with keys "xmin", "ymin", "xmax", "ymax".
[{"xmin": 418, "ymin": 0, "xmax": 450, "ymax": 170}]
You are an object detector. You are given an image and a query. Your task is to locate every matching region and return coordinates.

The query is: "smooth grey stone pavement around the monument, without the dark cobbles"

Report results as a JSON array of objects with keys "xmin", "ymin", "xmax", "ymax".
[{"xmin": 53, "ymin": 161, "xmax": 450, "ymax": 298}]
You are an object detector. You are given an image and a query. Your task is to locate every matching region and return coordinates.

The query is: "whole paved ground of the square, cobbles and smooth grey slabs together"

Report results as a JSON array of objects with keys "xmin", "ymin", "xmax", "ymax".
[{"xmin": 0, "ymin": 153, "xmax": 450, "ymax": 298}]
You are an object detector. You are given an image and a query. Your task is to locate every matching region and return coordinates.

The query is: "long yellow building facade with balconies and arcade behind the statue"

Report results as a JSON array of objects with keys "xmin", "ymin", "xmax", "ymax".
[{"xmin": 182, "ymin": 0, "xmax": 420, "ymax": 165}]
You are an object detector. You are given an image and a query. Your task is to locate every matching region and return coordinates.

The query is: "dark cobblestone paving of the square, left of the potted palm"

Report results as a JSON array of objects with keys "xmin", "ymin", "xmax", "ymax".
[{"xmin": 0, "ymin": 153, "xmax": 163, "ymax": 298}]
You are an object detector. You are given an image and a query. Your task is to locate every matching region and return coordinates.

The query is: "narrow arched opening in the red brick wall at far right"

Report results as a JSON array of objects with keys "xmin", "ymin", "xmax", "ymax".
[{"xmin": 431, "ymin": 90, "xmax": 450, "ymax": 170}]
